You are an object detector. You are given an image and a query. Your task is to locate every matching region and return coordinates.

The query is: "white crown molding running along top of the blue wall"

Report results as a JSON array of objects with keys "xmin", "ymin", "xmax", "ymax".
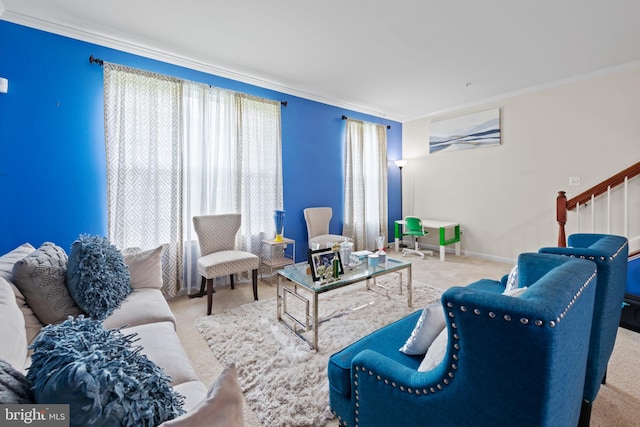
[{"xmin": 0, "ymin": 9, "xmax": 402, "ymax": 122}]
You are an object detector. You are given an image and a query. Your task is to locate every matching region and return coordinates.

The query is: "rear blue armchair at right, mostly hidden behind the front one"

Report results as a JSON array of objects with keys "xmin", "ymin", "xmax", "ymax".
[{"xmin": 539, "ymin": 234, "xmax": 629, "ymax": 426}]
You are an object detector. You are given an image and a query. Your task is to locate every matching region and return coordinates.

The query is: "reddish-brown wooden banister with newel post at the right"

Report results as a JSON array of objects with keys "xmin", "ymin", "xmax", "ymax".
[{"xmin": 556, "ymin": 162, "xmax": 640, "ymax": 248}]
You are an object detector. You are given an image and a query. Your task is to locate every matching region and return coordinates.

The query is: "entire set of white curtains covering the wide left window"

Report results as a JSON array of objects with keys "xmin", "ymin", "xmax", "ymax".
[{"xmin": 104, "ymin": 67, "xmax": 283, "ymax": 296}]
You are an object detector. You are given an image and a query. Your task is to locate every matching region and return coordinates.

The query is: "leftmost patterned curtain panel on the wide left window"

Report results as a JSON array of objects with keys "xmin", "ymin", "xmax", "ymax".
[{"xmin": 104, "ymin": 62, "xmax": 184, "ymax": 296}]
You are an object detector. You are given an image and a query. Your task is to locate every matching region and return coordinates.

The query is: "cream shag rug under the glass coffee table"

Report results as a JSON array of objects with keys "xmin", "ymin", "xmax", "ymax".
[{"xmin": 196, "ymin": 274, "xmax": 440, "ymax": 426}]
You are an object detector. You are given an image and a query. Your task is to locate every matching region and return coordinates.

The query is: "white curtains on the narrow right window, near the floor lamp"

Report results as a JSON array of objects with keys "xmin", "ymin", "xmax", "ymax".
[{"xmin": 343, "ymin": 119, "xmax": 389, "ymax": 250}]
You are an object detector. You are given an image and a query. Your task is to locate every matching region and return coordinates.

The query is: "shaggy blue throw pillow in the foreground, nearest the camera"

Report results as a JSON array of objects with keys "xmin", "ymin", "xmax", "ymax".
[{"xmin": 27, "ymin": 315, "xmax": 184, "ymax": 426}]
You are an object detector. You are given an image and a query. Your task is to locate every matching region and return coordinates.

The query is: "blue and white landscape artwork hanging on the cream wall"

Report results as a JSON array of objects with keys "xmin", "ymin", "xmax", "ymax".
[{"xmin": 429, "ymin": 108, "xmax": 500, "ymax": 153}]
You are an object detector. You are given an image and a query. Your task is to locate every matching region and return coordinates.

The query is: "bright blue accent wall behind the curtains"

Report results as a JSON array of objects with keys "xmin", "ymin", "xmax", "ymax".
[{"xmin": 0, "ymin": 20, "xmax": 402, "ymax": 260}]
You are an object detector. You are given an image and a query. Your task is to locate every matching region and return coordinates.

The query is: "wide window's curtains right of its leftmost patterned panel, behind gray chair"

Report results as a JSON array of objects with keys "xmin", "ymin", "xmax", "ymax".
[{"xmin": 184, "ymin": 82, "xmax": 283, "ymax": 292}]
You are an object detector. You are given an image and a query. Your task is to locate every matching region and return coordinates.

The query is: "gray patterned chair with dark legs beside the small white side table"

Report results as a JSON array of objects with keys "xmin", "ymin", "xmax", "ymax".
[{"xmin": 193, "ymin": 214, "xmax": 260, "ymax": 314}]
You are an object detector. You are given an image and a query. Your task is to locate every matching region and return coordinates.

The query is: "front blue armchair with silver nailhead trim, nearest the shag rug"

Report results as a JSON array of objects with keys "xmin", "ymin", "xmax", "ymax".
[{"xmin": 328, "ymin": 254, "xmax": 596, "ymax": 427}]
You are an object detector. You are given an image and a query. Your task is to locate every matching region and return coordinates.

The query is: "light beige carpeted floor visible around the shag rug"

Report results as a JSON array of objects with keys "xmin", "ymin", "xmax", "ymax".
[{"xmin": 170, "ymin": 252, "xmax": 640, "ymax": 427}]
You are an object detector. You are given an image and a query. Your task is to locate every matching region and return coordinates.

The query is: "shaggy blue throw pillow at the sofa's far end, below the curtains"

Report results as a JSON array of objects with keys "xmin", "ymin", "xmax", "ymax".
[{"xmin": 67, "ymin": 234, "xmax": 132, "ymax": 320}]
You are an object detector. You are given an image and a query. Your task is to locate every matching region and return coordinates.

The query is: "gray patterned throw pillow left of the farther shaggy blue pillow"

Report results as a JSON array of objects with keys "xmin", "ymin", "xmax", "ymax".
[{"xmin": 13, "ymin": 242, "xmax": 82, "ymax": 325}]
